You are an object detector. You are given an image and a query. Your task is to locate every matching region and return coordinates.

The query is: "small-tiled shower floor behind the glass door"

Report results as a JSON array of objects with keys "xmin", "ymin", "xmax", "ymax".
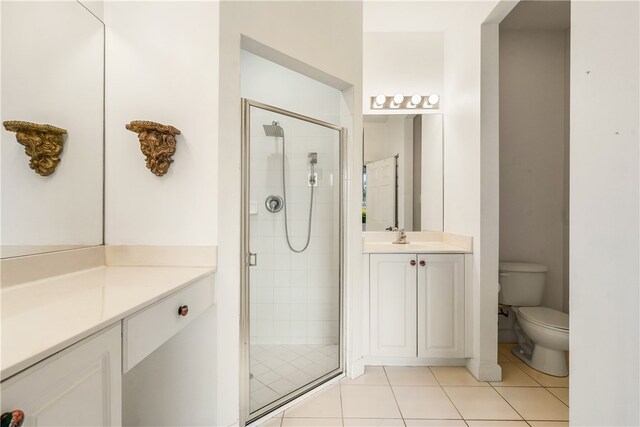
[{"xmin": 250, "ymin": 344, "xmax": 339, "ymax": 411}]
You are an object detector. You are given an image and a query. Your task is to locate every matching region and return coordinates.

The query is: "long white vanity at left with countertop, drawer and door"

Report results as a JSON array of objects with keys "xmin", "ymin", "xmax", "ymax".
[{"xmin": 0, "ymin": 267, "xmax": 214, "ymax": 427}]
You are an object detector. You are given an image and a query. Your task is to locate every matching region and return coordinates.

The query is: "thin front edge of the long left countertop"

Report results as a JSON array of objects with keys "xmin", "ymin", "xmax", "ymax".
[{"xmin": 0, "ymin": 267, "xmax": 217, "ymax": 382}]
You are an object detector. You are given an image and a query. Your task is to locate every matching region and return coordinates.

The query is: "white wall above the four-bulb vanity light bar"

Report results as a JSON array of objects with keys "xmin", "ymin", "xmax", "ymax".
[{"xmin": 362, "ymin": 32, "xmax": 444, "ymax": 114}]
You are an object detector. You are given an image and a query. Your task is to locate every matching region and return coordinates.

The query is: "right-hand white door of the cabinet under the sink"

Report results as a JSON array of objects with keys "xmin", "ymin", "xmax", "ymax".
[{"xmin": 418, "ymin": 254, "xmax": 465, "ymax": 358}]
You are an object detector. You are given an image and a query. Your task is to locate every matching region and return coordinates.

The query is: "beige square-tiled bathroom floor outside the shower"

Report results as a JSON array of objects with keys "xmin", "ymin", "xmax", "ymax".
[{"xmin": 262, "ymin": 344, "xmax": 569, "ymax": 427}]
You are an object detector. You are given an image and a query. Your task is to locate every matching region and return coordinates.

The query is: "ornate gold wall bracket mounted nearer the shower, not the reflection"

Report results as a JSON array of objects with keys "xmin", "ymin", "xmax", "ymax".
[{"xmin": 126, "ymin": 120, "xmax": 180, "ymax": 176}]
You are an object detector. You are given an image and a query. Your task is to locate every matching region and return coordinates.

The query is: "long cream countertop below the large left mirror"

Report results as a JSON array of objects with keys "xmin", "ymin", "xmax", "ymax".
[{"xmin": 0, "ymin": 267, "xmax": 215, "ymax": 380}]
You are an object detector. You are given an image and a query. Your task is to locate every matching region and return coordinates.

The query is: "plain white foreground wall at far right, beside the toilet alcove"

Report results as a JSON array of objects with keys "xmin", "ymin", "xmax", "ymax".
[{"xmin": 570, "ymin": 1, "xmax": 640, "ymax": 426}]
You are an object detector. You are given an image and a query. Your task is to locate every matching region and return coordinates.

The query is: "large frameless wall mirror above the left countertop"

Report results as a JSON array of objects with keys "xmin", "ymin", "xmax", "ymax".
[{"xmin": 0, "ymin": 1, "xmax": 104, "ymax": 258}]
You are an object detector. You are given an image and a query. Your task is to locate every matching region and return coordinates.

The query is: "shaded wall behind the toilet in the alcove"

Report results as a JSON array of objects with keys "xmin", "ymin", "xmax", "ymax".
[{"xmin": 500, "ymin": 30, "xmax": 569, "ymax": 310}]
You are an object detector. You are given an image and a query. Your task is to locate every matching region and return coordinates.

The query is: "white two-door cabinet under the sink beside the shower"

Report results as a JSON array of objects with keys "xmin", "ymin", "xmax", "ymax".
[{"xmin": 369, "ymin": 253, "xmax": 465, "ymax": 360}]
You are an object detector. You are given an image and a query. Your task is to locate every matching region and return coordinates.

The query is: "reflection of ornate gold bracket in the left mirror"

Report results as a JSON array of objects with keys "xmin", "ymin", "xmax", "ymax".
[{"xmin": 3, "ymin": 120, "xmax": 67, "ymax": 176}]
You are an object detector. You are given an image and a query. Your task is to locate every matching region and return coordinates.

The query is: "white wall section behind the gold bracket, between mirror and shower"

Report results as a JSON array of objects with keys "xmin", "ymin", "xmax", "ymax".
[{"xmin": 105, "ymin": 1, "xmax": 218, "ymax": 246}]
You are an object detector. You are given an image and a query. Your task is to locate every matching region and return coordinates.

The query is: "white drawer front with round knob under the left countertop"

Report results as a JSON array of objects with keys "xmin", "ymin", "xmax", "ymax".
[{"xmin": 122, "ymin": 275, "xmax": 213, "ymax": 372}]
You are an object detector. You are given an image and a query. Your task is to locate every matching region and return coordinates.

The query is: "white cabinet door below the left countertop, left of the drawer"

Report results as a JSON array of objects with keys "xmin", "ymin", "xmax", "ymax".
[{"xmin": 1, "ymin": 324, "xmax": 122, "ymax": 426}]
